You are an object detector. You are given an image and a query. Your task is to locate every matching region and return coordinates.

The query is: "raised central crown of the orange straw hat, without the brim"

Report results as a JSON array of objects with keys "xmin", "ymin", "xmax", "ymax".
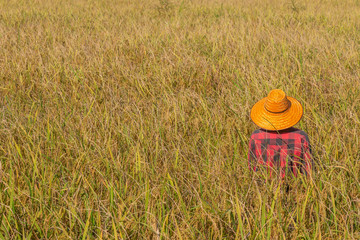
[{"xmin": 265, "ymin": 89, "xmax": 291, "ymax": 113}]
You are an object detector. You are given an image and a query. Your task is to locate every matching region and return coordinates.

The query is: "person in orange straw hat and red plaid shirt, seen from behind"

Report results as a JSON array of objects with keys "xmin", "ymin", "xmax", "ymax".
[{"xmin": 248, "ymin": 89, "xmax": 313, "ymax": 178}]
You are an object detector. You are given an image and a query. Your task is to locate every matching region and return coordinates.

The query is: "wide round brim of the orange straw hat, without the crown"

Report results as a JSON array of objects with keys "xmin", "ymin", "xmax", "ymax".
[{"xmin": 250, "ymin": 97, "xmax": 303, "ymax": 131}]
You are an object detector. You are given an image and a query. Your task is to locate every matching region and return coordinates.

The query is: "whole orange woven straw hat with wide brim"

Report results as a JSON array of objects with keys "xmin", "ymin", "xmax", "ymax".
[{"xmin": 251, "ymin": 89, "xmax": 303, "ymax": 131}]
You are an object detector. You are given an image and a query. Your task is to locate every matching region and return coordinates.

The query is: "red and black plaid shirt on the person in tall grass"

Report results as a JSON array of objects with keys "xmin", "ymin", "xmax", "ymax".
[{"xmin": 248, "ymin": 128, "xmax": 313, "ymax": 178}]
